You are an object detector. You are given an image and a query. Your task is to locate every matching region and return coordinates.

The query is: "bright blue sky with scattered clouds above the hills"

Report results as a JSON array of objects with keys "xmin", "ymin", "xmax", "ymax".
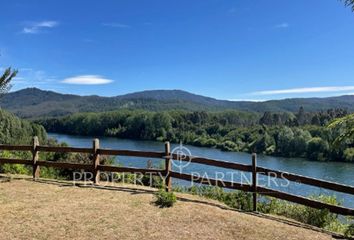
[{"xmin": 0, "ymin": 0, "xmax": 354, "ymax": 100}]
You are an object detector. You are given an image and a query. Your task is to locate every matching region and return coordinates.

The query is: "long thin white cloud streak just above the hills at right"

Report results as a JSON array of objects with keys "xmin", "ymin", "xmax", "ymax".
[{"xmin": 251, "ymin": 86, "xmax": 354, "ymax": 95}]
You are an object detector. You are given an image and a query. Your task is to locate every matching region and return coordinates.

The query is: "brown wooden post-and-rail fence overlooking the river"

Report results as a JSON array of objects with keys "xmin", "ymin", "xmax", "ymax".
[{"xmin": 0, "ymin": 137, "xmax": 354, "ymax": 216}]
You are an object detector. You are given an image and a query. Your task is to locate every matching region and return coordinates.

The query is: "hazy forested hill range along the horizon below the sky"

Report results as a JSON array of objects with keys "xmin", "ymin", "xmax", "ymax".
[{"xmin": 0, "ymin": 88, "xmax": 354, "ymax": 118}]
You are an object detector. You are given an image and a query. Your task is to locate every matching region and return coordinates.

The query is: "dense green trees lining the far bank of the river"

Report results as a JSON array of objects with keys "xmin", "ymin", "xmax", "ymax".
[{"xmin": 40, "ymin": 108, "xmax": 354, "ymax": 162}]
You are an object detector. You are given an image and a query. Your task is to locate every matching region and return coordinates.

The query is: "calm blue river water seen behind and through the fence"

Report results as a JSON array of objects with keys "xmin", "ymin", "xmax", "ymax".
[{"xmin": 49, "ymin": 133, "xmax": 354, "ymax": 208}]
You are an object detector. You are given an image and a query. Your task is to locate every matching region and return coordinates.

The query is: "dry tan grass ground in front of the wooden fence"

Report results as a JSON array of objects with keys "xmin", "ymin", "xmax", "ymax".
[{"xmin": 0, "ymin": 176, "xmax": 331, "ymax": 240}]
